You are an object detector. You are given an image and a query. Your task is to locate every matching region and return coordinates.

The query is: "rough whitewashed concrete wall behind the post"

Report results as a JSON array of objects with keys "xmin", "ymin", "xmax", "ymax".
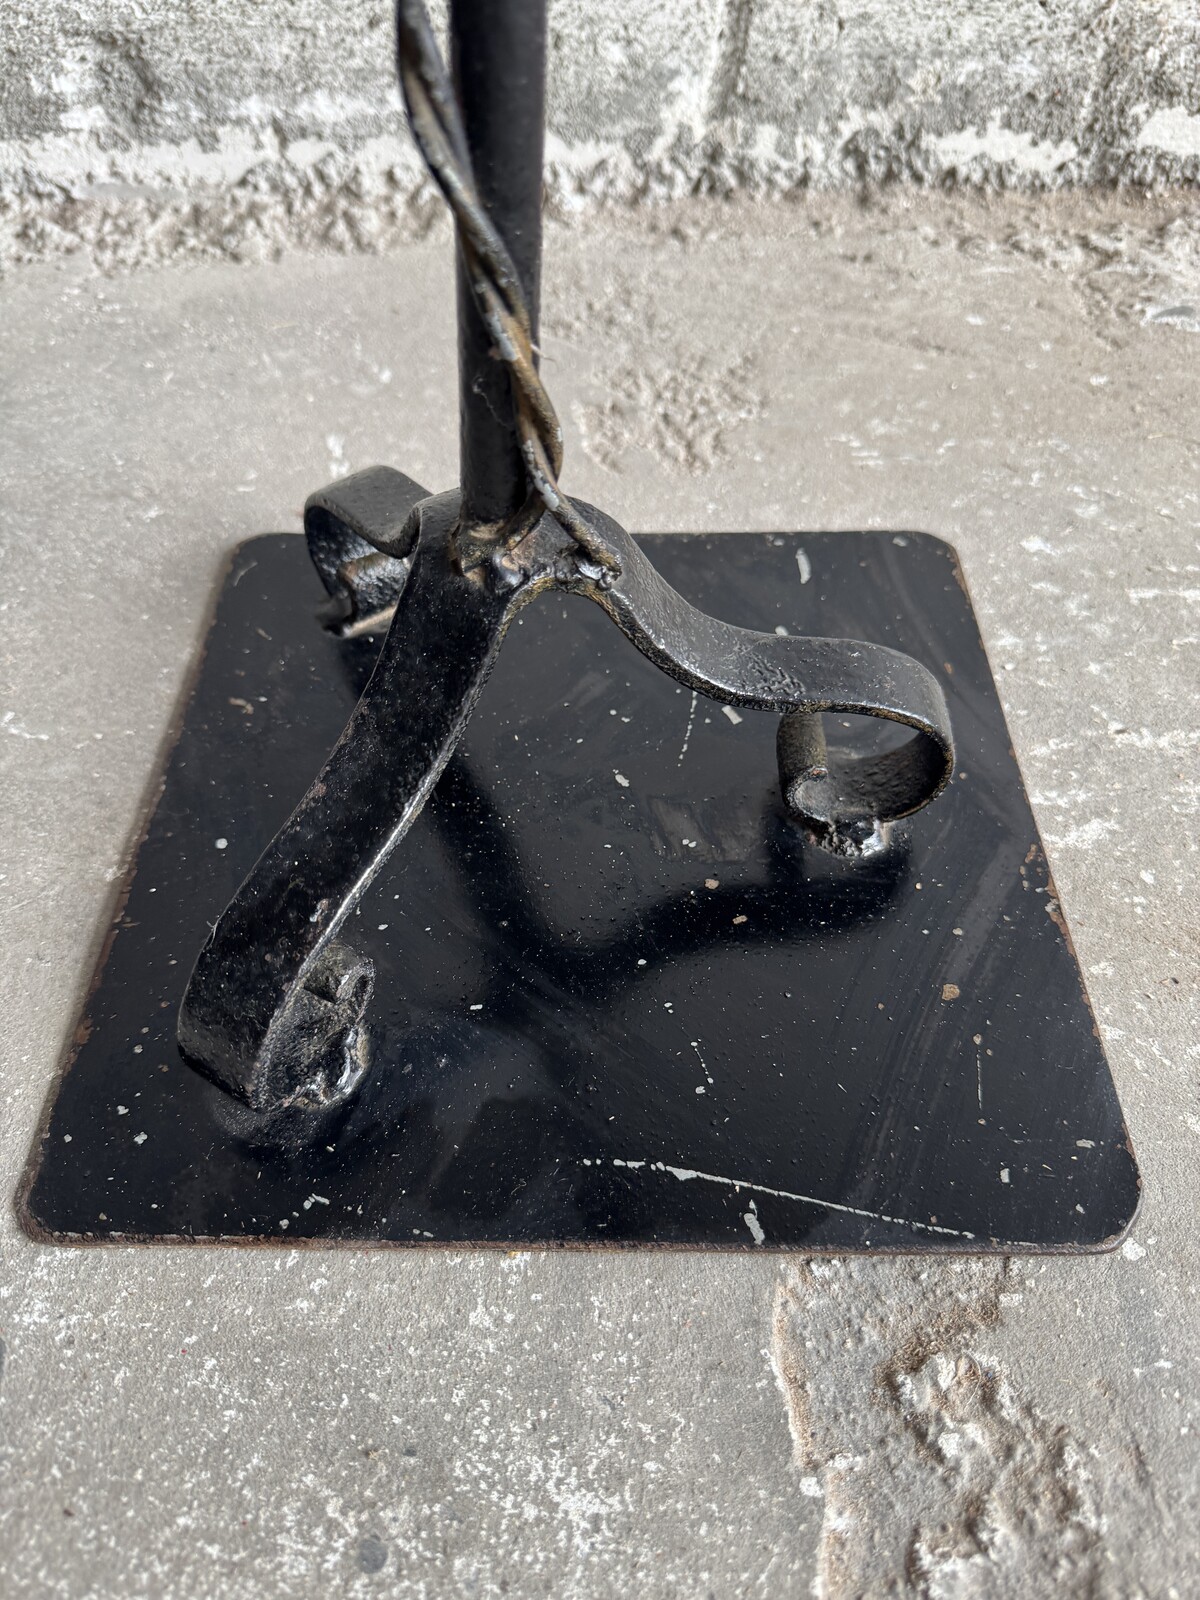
[{"xmin": 0, "ymin": 0, "xmax": 1200, "ymax": 264}]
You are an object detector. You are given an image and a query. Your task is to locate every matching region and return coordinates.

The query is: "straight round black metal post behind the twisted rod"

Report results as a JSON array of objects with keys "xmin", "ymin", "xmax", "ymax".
[{"xmin": 450, "ymin": 0, "xmax": 546, "ymax": 523}]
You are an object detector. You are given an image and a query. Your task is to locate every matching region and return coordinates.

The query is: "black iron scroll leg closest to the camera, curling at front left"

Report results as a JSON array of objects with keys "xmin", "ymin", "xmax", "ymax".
[{"xmin": 179, "ymin": 494, "xmax": 528, "ymax": 1109}]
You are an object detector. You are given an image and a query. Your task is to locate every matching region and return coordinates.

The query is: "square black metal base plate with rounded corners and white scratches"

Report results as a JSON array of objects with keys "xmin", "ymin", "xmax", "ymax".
[{"xmin": 19, "ymin": 533, "xmax": 1139, "ymax": 1251}]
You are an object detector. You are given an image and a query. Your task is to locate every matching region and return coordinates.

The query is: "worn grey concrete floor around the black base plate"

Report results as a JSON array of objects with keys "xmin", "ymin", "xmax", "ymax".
[{"xmin": 0, "ymin": 197, "xmax": 1200, "ymax": 1600}]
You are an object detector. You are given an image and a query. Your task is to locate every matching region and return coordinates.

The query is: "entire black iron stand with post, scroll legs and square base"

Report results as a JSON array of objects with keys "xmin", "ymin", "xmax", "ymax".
[{"xmin": 22, "ymin": 0, "xmax": 1138, "ymax": 1250}]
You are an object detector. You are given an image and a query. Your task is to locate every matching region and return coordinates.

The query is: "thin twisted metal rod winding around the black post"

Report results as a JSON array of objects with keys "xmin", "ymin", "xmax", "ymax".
[{"xmin": 395, "ymin": 0, "xmax": 621, "ymax": 578}]
